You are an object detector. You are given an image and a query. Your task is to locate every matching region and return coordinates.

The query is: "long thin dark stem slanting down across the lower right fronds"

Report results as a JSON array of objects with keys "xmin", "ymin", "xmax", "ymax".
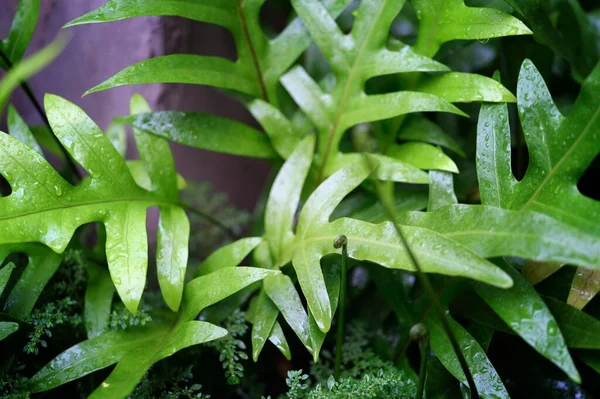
[{"xmin": 365, "ymin": 157, "xmax": 479, "ymax": 399}]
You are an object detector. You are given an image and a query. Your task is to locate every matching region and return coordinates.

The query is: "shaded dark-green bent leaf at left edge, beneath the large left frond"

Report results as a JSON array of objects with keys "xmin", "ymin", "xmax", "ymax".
[{"xmin": 0, "ymin": 245, "xmax": 62, "ymax": 320}]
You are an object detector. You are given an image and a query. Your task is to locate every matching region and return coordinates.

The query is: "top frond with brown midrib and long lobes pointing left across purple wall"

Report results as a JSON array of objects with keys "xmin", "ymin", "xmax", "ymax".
[{"xmin": 65, "ymin": 0, "xmax": 349, "ymax": 102}]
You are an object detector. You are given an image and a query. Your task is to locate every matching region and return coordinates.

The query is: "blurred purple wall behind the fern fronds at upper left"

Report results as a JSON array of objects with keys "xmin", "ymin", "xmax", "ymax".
[{"xmin": 0, "ymin": 0, "xmax": 269, "ymax": 209}]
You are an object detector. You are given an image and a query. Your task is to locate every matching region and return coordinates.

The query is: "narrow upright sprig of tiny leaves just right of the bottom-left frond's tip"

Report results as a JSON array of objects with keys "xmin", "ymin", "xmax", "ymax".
[{"xmin": 208, "ymin": 309, "xmax": 248, "ymax": 385}]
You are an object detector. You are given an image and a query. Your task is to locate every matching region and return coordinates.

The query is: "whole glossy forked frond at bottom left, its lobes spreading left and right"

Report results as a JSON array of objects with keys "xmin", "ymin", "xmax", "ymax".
[{"xmin": 27, "ymin": 267, "xmax": 278, "ymax": 398}]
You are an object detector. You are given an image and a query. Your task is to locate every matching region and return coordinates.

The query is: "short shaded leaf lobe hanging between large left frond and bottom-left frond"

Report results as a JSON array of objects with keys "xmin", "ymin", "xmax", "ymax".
[{"xmin": 83, "ymin": 262, "xmax": 115, "ymax": 338}]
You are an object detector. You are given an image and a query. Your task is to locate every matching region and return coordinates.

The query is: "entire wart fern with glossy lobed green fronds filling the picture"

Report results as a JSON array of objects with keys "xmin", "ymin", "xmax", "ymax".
[{"xmin": 0, "ymin": 0, "xmax": 600, "ymax": 398}]
